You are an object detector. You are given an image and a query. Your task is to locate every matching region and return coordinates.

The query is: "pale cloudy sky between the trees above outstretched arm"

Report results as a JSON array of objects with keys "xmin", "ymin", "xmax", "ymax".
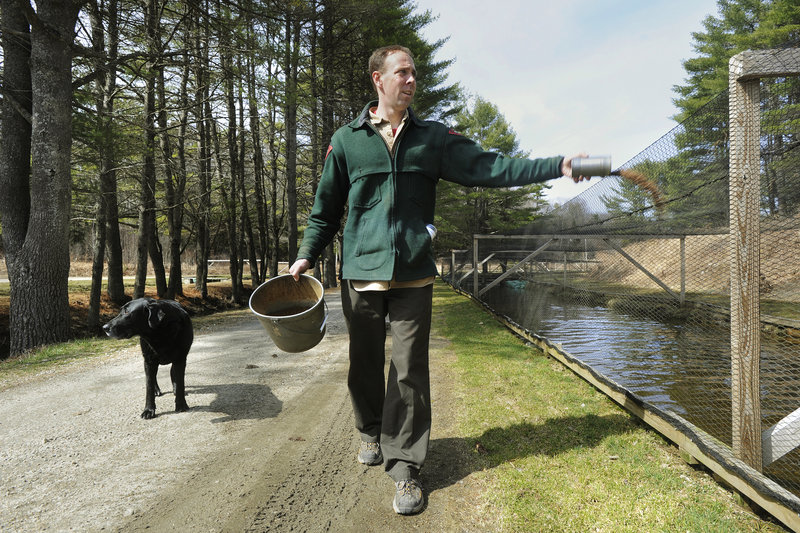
[{"xmin": 416, "ymin": 0, "xmax": 719, "ymax": 203}]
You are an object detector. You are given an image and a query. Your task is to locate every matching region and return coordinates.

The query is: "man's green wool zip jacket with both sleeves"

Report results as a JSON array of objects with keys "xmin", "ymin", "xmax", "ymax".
[{"xmin": 297, "ymin": 102, "xmax": 563, "ymax": 281}]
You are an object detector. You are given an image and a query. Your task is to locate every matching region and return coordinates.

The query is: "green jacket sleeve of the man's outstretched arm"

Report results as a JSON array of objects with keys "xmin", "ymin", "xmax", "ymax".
[{"xmin": 440, "ymin": 130, "xmax": 564, "ymax": 187}]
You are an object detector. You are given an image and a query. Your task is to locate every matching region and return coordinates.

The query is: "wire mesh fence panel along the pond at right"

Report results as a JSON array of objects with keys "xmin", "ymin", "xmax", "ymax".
[{"xmin": 445, "ymin": 45, "xmax": 800, "ymax": 520}]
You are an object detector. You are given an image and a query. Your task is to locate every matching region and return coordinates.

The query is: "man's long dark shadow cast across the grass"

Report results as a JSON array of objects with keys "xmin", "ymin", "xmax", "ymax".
[{"xmin": 420, "ymin": 415, "xmax": 631, "ymax": 492}]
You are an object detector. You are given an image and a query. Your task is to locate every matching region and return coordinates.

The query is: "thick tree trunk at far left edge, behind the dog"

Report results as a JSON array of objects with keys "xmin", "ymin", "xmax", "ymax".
[{"xmin": 0, "ymin": 0, "xmax": 78, "ymax": 354}]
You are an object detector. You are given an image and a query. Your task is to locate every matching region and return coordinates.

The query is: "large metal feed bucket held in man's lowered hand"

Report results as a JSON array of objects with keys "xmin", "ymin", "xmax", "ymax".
[{"xmin": 250, "ymin": 274, "xmax": 328, "ymax": 353}]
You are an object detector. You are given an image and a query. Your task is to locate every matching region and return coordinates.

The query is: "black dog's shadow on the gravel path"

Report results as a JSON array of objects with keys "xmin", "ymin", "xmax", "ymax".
[{"xmin": 186, "ymin": 383, "xmax": 283, "ymax": 424}]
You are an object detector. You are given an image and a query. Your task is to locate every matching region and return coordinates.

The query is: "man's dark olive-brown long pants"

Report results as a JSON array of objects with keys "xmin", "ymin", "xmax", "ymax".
[{"xmin": 342, "ymin": 280, "xmax": 433, "ymax": 481}]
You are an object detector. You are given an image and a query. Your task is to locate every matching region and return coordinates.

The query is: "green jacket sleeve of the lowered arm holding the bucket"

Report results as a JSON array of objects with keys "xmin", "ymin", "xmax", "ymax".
[{"xmin": 297, "ymin": 136, "xmax": 350, "ymax": 266}]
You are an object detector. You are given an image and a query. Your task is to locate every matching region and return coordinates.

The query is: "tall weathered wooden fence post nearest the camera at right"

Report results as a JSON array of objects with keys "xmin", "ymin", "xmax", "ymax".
[{"xmin": 728, "ymin": 52, "xmax": 762, "ymax": 471}]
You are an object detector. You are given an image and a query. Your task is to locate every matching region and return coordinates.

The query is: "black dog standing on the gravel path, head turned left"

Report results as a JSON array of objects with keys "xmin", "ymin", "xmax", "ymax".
[{"xmin": 103, "ymin": 298, "xmax": 194, "ymax": 419}]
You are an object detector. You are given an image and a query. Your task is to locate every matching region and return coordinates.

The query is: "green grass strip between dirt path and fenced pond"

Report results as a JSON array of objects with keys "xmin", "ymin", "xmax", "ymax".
[{"xmin": 433, "ymin": 283, "xmax": 783, "ymax": 532}]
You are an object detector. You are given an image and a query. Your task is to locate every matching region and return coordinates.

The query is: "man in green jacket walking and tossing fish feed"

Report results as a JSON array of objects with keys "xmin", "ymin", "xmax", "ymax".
[{"xmin": 289, "ymin": 45, "xmax": 583, "ymax": 514}]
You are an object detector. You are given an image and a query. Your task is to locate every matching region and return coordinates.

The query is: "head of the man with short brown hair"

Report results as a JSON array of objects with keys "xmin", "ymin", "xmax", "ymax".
[{"xmin": 369, "ymin": 45, "xmax": 417, "ymax": 109}]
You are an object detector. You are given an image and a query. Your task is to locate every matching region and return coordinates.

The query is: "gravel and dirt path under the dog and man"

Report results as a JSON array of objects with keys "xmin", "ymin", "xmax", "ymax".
[{"xmin": 0, "ymin": 292, "xmax": 488, "ymax": 532}]
